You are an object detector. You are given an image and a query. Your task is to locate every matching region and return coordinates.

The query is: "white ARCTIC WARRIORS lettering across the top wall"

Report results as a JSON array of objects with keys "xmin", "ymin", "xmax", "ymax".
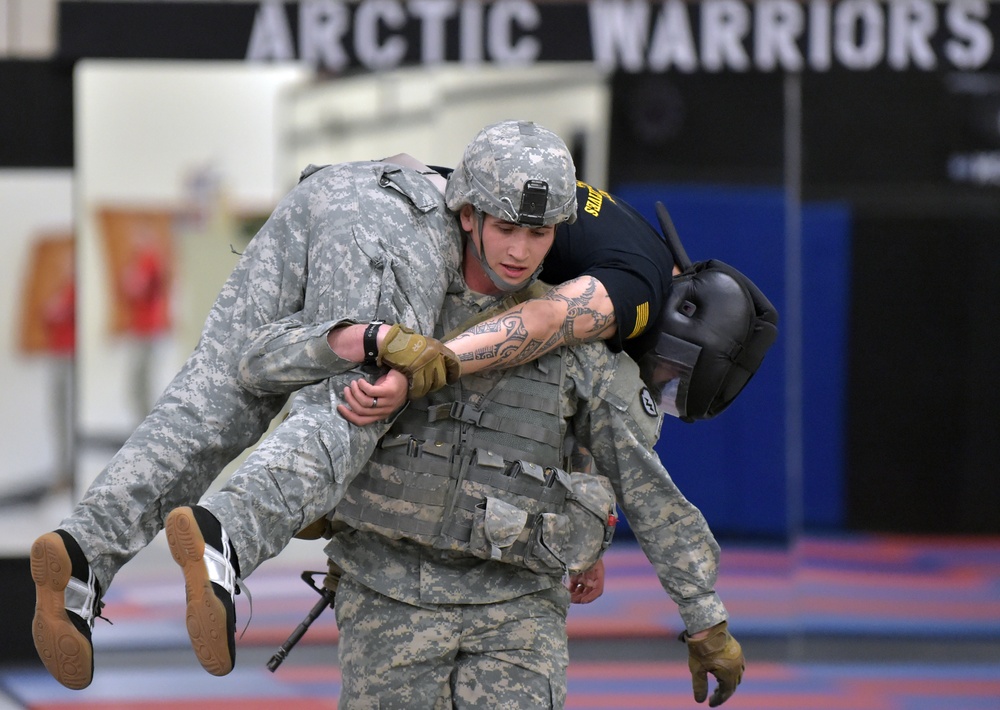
[{"xmin": 247, "ymin": 0, "xmax": 1000, "ymax": 72}]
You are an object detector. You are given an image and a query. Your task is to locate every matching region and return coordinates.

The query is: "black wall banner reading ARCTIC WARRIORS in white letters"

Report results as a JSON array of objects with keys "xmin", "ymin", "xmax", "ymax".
[{"xmin": 59, "ymin": 0, "xmax": 1000, "ymax": 73}]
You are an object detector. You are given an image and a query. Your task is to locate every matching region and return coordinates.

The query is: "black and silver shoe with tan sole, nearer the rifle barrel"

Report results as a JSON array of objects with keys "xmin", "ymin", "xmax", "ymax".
[{"xmin": 166, "ymin": 505, "xmax": 240, "ymax": 675}]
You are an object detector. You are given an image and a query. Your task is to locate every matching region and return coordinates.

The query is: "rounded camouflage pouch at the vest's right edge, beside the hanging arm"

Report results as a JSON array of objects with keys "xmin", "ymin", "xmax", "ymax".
[{"xmin": 561, "ymin": 473, "xmax": 618, "ymax": 574}]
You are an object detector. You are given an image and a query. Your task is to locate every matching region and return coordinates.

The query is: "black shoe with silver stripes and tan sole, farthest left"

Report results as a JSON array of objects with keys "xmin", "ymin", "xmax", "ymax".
[{"xmin": 31, "ymin": 530, "xmax": 102, "ymax": 690}]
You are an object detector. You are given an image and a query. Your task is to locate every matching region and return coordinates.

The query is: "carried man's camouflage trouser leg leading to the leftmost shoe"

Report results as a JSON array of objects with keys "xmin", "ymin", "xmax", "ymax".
[{"xmin": 59, "ymin": 213, "xmax": 300, "ymax": 591}]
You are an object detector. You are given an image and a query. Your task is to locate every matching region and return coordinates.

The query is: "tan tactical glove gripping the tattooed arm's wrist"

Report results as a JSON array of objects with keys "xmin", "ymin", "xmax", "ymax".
[{"xmin": 378, "ymin": 325, "xmax": 462, "ymax": 399}]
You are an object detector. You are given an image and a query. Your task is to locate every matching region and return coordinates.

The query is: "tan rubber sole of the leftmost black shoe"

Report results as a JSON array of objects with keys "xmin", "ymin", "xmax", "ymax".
[{"xmin": 31, "ymin": 532, "xmax": 94, "ymax": 690}]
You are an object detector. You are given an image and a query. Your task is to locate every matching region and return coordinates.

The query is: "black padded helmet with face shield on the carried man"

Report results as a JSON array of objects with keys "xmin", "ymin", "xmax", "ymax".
[{"xmin": 639, "ymin": 202, "xmax": 778, "ymax": 422}]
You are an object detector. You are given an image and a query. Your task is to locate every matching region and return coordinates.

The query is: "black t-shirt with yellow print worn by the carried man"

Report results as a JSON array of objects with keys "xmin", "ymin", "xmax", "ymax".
[{"xmin": 541, "ymin": 181, "xmax": 674, "ymax": 357}]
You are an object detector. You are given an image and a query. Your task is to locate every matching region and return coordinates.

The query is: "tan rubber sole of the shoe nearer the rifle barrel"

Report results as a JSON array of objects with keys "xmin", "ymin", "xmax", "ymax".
[{"xmin": 165, "ymin": 508, "xmax": 233, "ymax": 675}]
